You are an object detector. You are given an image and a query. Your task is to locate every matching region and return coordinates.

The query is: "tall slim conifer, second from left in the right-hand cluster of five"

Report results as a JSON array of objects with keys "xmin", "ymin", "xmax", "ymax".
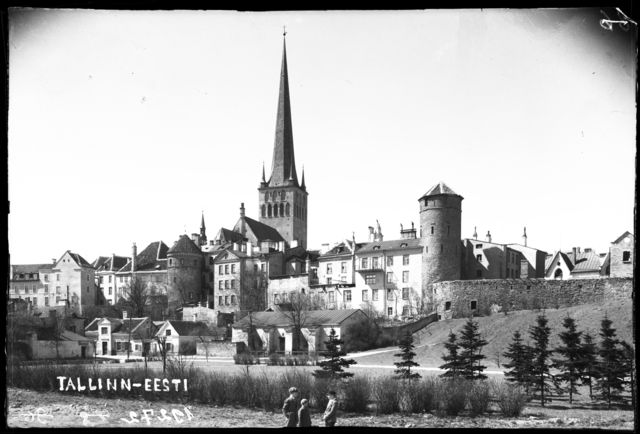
[{"xmin": 529, "ymin": 313, "xmax": 553, "ymax": 407}]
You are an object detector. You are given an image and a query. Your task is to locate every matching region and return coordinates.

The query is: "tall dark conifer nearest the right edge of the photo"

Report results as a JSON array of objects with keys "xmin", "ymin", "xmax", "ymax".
[{"xmin": 597, "ymin": 315, "xmax": 624, "ymax": 408}]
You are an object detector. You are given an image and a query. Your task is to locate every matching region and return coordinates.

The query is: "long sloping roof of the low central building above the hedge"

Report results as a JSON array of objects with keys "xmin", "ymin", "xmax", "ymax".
[{"xmin": 233, "ymin": 309, "xmax": 364, "ymax": 328}]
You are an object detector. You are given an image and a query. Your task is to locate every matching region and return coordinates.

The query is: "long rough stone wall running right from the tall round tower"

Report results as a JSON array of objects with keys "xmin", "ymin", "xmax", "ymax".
[{"xmin": 433, "ymin": 278, "xmax": 633, "ymax": 319}]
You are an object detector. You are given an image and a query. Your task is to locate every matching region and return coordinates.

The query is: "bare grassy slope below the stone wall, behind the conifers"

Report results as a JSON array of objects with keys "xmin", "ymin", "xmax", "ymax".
[{"xmin": 357, "ymin": 300, "xmax": 633, "ymax": 369}]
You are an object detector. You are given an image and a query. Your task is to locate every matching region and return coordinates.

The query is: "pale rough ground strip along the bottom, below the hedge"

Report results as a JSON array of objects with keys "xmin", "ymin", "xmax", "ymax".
[{"xmin": 7, "ymin": 388, "xmax": 633, "ymax": 430}]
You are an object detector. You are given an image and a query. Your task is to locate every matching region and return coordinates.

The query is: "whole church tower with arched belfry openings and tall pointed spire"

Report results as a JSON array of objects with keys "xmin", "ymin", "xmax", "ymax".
[{"xmin": 258, "ymin": 34, "xmax": 308, "ymax": 249}]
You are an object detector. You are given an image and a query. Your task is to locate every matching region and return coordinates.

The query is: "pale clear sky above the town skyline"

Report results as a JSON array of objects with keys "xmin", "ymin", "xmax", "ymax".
[{"xmin": 8, "ymin": 9, "xmax": 636, "ymax": 264}]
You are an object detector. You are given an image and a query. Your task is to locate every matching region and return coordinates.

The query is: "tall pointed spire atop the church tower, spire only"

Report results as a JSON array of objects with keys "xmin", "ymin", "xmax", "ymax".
[{"xmin": 269, "ymin": 34, "xmax": 298, "ymax": 187}]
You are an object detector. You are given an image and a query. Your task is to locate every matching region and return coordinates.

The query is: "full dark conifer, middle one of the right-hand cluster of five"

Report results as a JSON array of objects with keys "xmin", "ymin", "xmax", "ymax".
[{"xmin": 552, "ymin": 316, "xmax": 583, "ymax": 404}]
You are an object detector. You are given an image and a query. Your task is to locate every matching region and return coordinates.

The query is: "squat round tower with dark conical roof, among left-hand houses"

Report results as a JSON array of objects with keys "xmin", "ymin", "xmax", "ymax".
[{"xmin": 167, "ymin": 235, "xmax": 205, "ymax": 307}]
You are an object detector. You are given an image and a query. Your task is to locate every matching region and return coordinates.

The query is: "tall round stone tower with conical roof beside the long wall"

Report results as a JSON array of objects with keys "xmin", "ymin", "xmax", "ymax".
[{"xmin": 418, "ymin": 182, "xmax": 464, "ymax": 300}]
